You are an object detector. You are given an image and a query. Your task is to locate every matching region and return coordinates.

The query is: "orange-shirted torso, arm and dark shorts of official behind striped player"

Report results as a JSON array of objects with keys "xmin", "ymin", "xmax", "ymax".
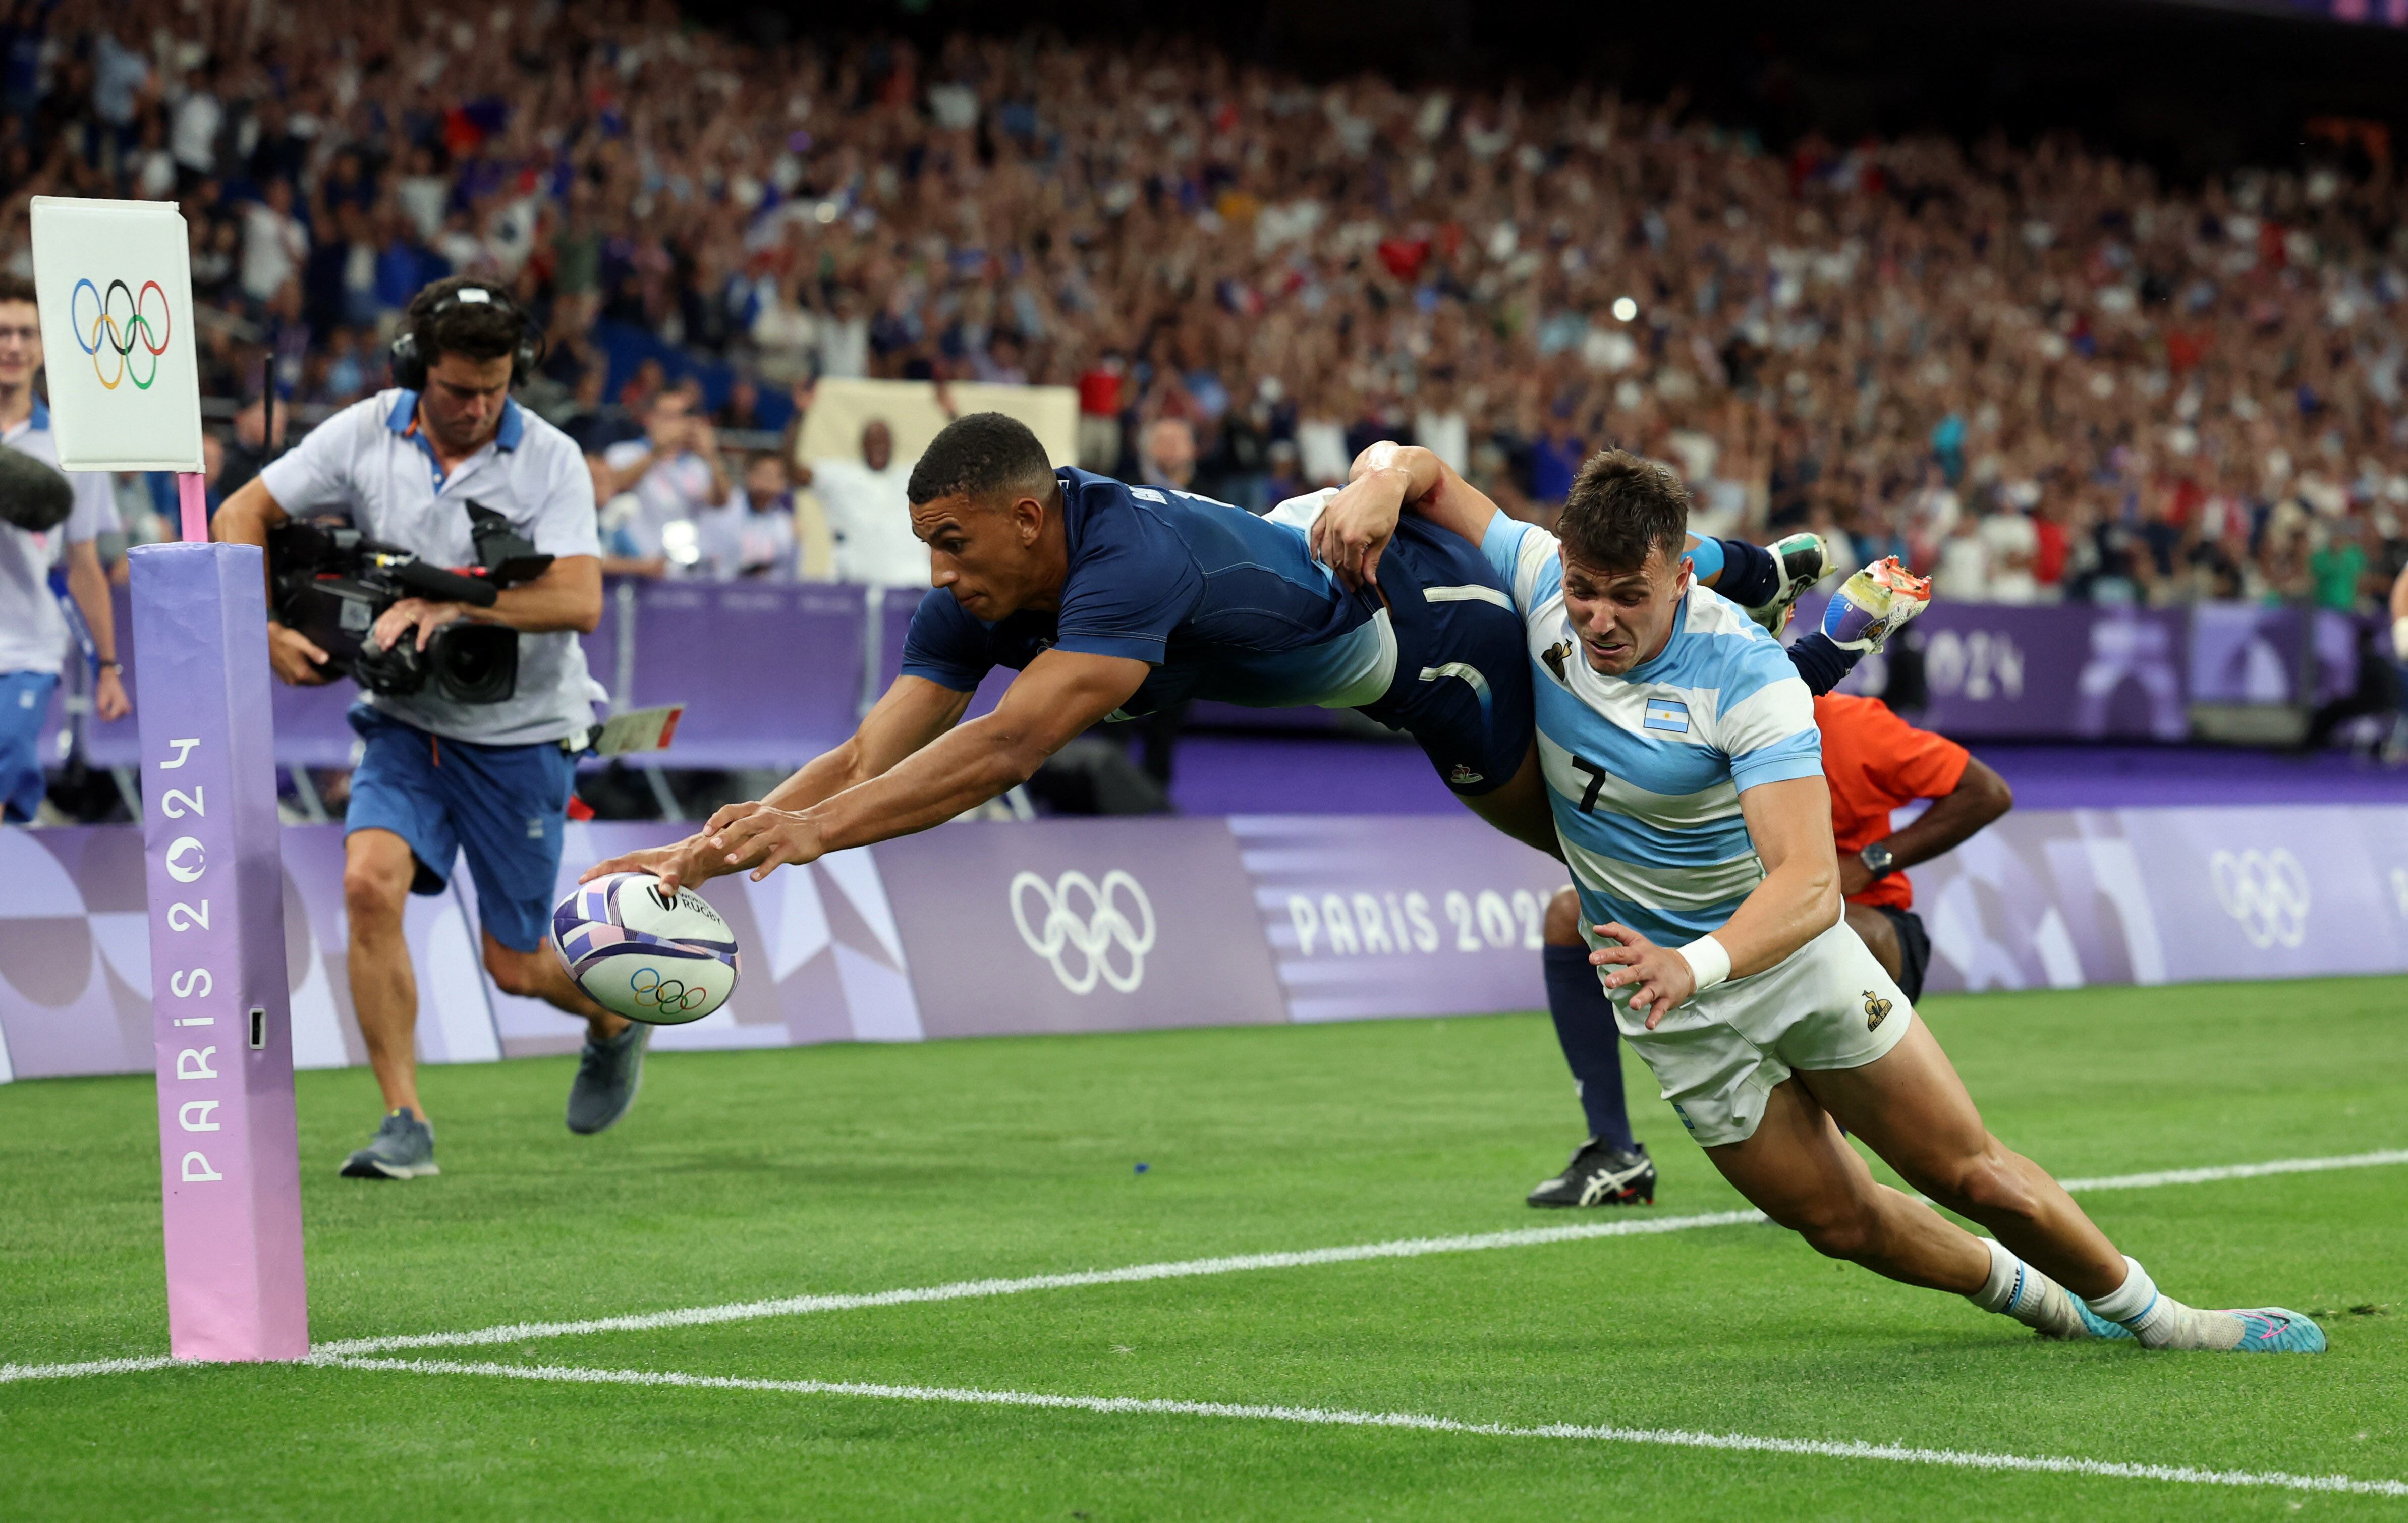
[{"xmin": 1813, "ymin": 693, "xmax": 2015, "ymax": 1001}]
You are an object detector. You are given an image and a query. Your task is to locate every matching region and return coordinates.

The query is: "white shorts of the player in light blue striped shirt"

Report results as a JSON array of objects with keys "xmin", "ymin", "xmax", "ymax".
[{"xmin": 1582, "ymin": 919, "xmax": 1915, "ymax": 1148}]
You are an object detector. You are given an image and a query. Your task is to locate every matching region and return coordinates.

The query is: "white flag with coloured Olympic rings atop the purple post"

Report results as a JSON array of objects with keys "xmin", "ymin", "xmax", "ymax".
[{"xmin": 34, "ymin": 195, "xmax": 202, "ymax": 472}]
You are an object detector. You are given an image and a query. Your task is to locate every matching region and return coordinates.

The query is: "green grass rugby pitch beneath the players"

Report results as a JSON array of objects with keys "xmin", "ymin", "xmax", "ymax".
[{"xmin": 0, "ymin": 979, "xmax": 2408, "ymax": 1523}]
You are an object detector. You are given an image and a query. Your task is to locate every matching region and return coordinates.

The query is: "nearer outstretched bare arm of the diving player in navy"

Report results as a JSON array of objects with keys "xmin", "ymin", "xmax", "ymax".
[{"xmin": 710, "ymin": 650, "xmax": 1151, "ymax": 883}]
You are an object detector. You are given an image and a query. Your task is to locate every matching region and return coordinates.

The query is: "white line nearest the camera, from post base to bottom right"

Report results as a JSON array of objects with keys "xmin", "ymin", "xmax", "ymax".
[{"xmin": 323, "ymin": 1360, "xmax": 2408, "ymax": 1497}]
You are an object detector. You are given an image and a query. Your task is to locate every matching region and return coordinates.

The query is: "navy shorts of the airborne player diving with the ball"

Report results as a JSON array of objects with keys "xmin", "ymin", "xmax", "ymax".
[{"xmin": 1363, "ymin": 517, "xmax": 1536, "ymax": 797}]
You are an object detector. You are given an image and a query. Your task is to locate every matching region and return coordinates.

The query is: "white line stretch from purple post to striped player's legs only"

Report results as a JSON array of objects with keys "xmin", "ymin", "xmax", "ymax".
[{"xmin": 313, "ymin": 1210, "xmax": 1765, "ymax": 1357}]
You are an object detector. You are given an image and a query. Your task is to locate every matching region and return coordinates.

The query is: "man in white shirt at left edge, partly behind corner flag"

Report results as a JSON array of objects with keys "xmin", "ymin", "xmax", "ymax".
[{"xmin": 0, "ymin": 274, "xmax": 130, "ymax": 820}]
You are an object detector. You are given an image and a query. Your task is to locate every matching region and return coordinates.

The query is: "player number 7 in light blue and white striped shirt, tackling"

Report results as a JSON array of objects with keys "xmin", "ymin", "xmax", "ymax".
[{"xmin": 1312, "ymin": 450, "xmax": 2324, "ymax": 1352}]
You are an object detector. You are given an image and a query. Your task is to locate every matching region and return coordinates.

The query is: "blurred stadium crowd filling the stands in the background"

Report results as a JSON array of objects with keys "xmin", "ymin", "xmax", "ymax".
[{"xmin": 0, "ymin": 0, "xmax": 2408, "ymax": 609}]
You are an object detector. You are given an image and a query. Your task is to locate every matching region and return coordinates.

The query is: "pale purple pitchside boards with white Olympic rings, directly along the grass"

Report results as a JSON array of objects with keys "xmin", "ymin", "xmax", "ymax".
[{"xmin": 0, "ymin": 804, "xmax": 2408, "ymax": 1078}]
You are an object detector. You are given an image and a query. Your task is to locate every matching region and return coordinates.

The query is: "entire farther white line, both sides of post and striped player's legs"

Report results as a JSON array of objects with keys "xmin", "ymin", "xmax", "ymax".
[{"xmin": 14, "ymin": 1148, "xmax": 2408, "ymax": 1383}]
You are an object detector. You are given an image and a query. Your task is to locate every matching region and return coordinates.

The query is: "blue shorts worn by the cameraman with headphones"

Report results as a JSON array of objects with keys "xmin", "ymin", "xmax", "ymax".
[{"xmin": 342, "ymin": 705, "xmax": 578, "ymax": 953}]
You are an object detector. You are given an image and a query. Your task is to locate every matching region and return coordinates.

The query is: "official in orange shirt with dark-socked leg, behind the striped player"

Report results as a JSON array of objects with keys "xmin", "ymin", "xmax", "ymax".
[{"xmin": 1524, "ymin": 693, "xmax": 2015, "ymax": 1205}]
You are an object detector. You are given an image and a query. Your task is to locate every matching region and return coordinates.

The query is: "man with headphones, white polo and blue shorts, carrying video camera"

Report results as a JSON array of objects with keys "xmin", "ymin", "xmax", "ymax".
[{"xmin": 217, "ymin": 279, "xmax": 650, "ymax": 1179}]
